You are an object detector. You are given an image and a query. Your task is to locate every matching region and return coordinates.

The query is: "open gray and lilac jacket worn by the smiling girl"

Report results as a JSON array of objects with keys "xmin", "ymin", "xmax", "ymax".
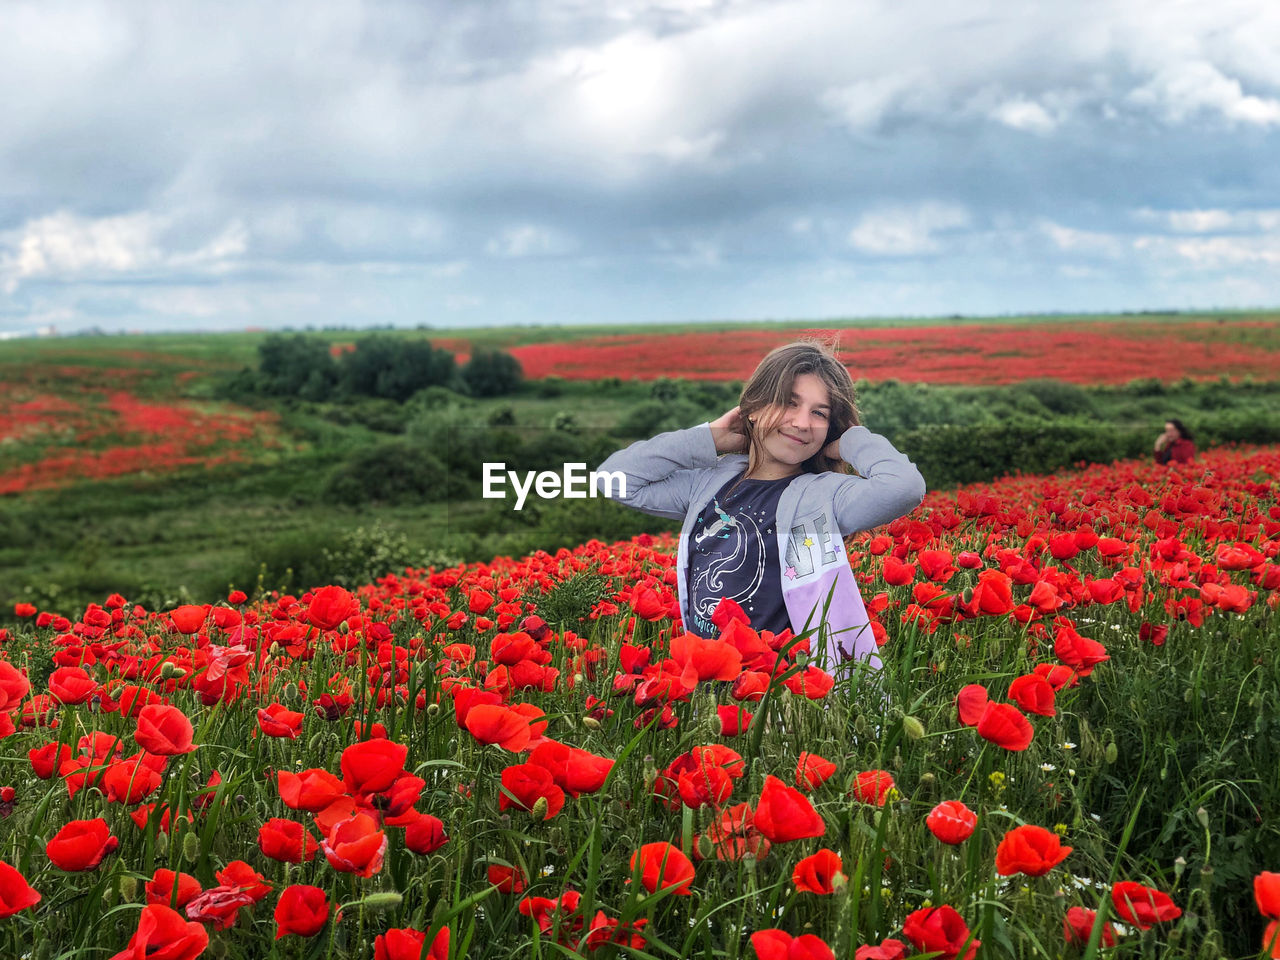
[{"xmin": 596, "ymin": 424, "xmax": 924, "ymax": 668}]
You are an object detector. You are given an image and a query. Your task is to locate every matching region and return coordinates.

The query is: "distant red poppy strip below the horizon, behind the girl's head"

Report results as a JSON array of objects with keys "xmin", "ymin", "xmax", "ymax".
[{"xmin": 501, "ymin": 319, "xmax": 1280, "ymax": 384}]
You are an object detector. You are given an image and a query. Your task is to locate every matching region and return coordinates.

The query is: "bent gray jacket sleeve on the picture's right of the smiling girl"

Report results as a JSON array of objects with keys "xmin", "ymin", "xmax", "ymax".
[{"xmin": 835, "ymin": 426, "xmax": 924, "ymax": 535}]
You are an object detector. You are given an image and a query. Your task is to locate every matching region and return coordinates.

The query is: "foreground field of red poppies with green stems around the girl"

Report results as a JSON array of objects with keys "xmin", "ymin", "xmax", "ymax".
[{"xmin": 0, "ymin": 448, "xmax": 1280, "ymax": 960}]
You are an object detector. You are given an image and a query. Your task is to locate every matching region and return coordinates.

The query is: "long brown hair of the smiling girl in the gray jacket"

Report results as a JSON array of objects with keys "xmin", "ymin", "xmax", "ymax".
[{"xmin": 737, "ymin": 340, "xmax": 861, "ymax": 475}]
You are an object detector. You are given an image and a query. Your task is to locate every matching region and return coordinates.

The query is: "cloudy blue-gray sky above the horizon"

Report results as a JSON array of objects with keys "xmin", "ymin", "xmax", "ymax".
[{"xmin": 0, "ymin": 0, "xmax": 1280, "ymax": 333}]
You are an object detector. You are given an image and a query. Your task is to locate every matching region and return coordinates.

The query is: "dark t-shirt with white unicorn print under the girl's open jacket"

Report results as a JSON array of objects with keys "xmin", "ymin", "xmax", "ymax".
[{"xmin": 686, "ymin": 476, "xmax": 795, "ymax": 636}]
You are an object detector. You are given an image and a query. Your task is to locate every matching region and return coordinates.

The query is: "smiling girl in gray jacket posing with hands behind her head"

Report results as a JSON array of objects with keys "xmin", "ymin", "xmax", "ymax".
[{"xmin": 599, "ymin": 342, "xmax": 924, "ymax": 668}]
